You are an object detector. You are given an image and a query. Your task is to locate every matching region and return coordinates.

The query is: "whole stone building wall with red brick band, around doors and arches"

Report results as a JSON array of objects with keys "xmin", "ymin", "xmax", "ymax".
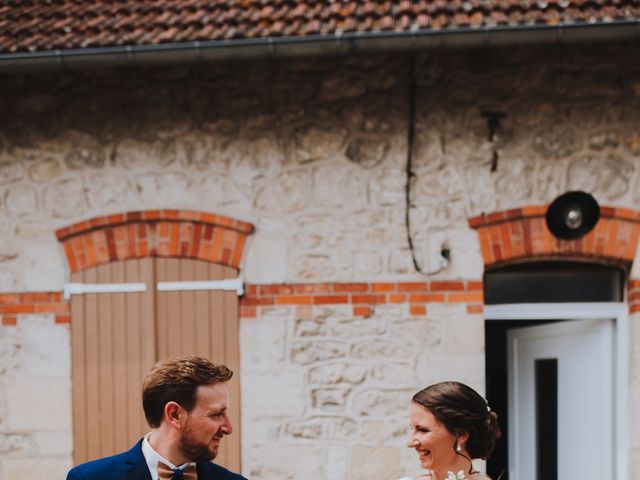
[{"xmin": 0, "ymin": 45, "xmax": 640, "ymax": 480}]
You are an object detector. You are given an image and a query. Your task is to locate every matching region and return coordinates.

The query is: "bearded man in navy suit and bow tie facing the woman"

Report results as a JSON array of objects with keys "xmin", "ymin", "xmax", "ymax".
[{"xmin": 67, "ymin": 356, "xmax": 246, "ymax": 480}]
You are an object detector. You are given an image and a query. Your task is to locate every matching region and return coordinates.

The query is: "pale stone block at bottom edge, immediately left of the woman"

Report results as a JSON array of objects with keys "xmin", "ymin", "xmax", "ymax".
[{"xmin": 349, "ymin": 446, "xmax": 402, "ymax": 480}]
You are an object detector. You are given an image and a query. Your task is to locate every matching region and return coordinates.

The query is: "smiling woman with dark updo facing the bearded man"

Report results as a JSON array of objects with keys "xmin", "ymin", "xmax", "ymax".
[{"xmin": 400, "ymin": 382, "xmax": 501, "ymax": 480}]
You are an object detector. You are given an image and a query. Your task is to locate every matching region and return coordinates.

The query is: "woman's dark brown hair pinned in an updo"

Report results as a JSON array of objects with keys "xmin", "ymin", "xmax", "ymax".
[{"xmin": 412, "ymin": 382, "xmax": 502, "ymax": 459}]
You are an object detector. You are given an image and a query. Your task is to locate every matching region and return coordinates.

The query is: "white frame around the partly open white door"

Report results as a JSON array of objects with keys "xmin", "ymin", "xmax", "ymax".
[{"xmin": 484, "ymin": 302, "xmax": 629, "ymax": 480}]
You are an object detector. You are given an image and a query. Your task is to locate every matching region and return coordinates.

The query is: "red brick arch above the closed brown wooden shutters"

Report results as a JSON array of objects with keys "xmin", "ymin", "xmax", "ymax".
[{"xmin": 56, "ymin": 210, "xmax": 254, "ymax": 273}]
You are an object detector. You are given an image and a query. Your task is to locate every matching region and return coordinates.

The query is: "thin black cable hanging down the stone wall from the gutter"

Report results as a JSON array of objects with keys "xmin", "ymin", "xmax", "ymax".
[{"xmin": 404, "ymin": 53, "xmax": 451, "ymax": 275}]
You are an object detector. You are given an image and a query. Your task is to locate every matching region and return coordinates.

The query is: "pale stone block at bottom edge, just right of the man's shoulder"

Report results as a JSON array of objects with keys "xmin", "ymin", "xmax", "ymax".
[{"xmin": 242, "ymin": 442, "xmax": 326, "ymax": 480}]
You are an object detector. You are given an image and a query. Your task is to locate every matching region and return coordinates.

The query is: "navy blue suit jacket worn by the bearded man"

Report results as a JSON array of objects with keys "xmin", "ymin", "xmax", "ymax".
[{"xmin": 67, "ymin": 440, "xmax": 247, "ymax": 480}]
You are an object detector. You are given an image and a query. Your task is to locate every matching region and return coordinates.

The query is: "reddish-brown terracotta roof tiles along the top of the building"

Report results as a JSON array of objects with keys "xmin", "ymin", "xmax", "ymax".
[{"xmin": 0, "ymin": 0, "xmax": 640, "ymax": 53}]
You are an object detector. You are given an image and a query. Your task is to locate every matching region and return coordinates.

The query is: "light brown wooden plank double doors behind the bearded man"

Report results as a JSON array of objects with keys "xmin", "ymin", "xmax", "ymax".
[{"xmin": 71, "ymin": 258, "xmax": 240, "ymax": 471}]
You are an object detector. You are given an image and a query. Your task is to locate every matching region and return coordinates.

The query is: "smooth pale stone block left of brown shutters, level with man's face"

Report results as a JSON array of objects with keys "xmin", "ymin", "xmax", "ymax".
[{"xmin": 5, "ymin": 375, "xmax": 71, "ymax": 432}]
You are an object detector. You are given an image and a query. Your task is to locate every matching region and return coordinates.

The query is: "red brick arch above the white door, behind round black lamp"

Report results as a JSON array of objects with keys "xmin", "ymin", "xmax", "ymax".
[{"xmin": 469, "ymin": 205, "xmax": 640, "ymax": 267}]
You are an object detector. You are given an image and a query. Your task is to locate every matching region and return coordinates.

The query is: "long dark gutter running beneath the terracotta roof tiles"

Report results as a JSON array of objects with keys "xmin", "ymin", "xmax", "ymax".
[{"xmin": 0, "ymin": 19, "xmax": 640, "ymax": 74}]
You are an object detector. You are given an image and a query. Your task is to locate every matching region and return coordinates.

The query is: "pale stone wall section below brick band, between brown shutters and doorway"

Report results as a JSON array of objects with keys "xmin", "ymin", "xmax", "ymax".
[{"xmin": 240, "ymin": 304, "xmax": 484, "ymax": 480}]
